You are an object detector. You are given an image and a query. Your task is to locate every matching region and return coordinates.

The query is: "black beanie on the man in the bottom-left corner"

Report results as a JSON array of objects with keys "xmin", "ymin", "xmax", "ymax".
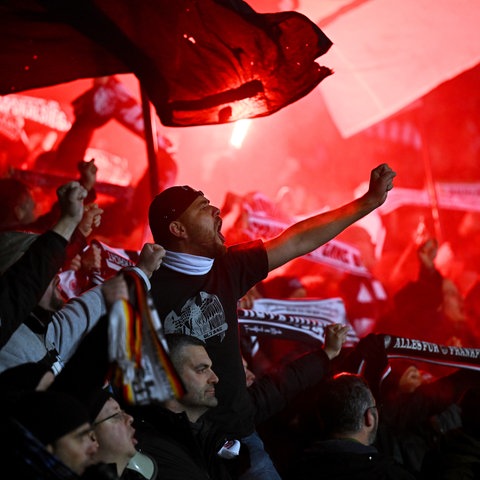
[{"xmin": 11, "ymin": 390, "xmax": 90, "ymax": 445}]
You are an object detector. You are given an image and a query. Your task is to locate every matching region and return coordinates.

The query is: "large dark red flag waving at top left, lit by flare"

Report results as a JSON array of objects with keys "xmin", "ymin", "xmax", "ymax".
[{"xmin": 0, "ymin": 0, "xmax": 332, "ymax": 126}]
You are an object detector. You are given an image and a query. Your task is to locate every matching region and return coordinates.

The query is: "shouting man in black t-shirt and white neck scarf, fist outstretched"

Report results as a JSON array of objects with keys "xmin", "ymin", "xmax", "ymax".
[{"xmin": 149, "ymin": 164, "xmax": 395, "ymax": 479}]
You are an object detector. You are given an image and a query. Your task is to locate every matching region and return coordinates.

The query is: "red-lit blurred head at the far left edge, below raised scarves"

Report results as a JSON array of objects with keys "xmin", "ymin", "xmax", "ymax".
[{"xmin": 0, "ymin": 178, "xmax": 35, "ymax": 228}]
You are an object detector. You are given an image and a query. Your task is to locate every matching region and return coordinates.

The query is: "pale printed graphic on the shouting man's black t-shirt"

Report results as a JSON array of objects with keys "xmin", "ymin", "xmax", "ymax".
[{"xmin": 164, "ymin": 292, "xmax": 228, "ymax": 341}]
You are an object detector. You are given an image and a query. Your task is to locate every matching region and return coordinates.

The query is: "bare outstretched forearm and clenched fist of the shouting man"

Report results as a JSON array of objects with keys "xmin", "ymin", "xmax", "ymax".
[{"xmin": 265, "ymin": 164, "xmax": 396, "ymax": 270}]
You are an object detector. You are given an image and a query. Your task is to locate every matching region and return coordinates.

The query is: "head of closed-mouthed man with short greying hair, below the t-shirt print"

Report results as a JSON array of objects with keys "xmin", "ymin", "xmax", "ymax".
[{"xmin": 166, "ymin": 334, "xmax": 218, "ymax": 422}]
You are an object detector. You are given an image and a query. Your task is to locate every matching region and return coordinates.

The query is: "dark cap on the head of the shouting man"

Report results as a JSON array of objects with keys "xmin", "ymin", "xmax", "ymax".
[{"xmin": 148, "ymin": 185, "xmax": 203, "ymax": 244}]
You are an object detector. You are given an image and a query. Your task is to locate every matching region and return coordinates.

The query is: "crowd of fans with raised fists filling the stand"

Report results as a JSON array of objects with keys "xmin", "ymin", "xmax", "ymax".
[{"xmin": 0, "ymin": 146, "xmax": 480, "ymax": 480}]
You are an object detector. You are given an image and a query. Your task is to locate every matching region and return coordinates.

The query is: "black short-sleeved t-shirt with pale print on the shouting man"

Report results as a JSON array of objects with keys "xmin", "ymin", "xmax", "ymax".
[{"xmin": 151, "ymin": 240, "xmax": 268, "ymax": 438}]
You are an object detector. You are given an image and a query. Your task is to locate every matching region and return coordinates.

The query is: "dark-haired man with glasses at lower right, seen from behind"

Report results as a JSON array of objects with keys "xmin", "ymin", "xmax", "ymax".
[{"xmin": 287, "ymin": 372, "xmax": 415, "ymax": 480}]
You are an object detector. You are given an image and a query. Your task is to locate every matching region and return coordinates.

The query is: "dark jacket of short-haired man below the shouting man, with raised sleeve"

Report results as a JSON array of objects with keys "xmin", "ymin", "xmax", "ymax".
[{"xmin": 127, "ymin": 350, "xmax": 330, "ymax": 480}]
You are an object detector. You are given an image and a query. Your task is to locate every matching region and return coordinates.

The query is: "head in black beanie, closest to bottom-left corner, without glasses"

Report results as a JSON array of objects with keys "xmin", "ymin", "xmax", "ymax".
[{"xmin": 11, "ymin": 390, "xmax": 98, "ymax": 475}]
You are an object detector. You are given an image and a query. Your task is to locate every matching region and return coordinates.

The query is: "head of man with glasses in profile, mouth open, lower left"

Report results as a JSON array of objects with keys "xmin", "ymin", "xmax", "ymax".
[{"xmin": 87, "ymin": 387, "xmax": 137, "ymax": 477}]
